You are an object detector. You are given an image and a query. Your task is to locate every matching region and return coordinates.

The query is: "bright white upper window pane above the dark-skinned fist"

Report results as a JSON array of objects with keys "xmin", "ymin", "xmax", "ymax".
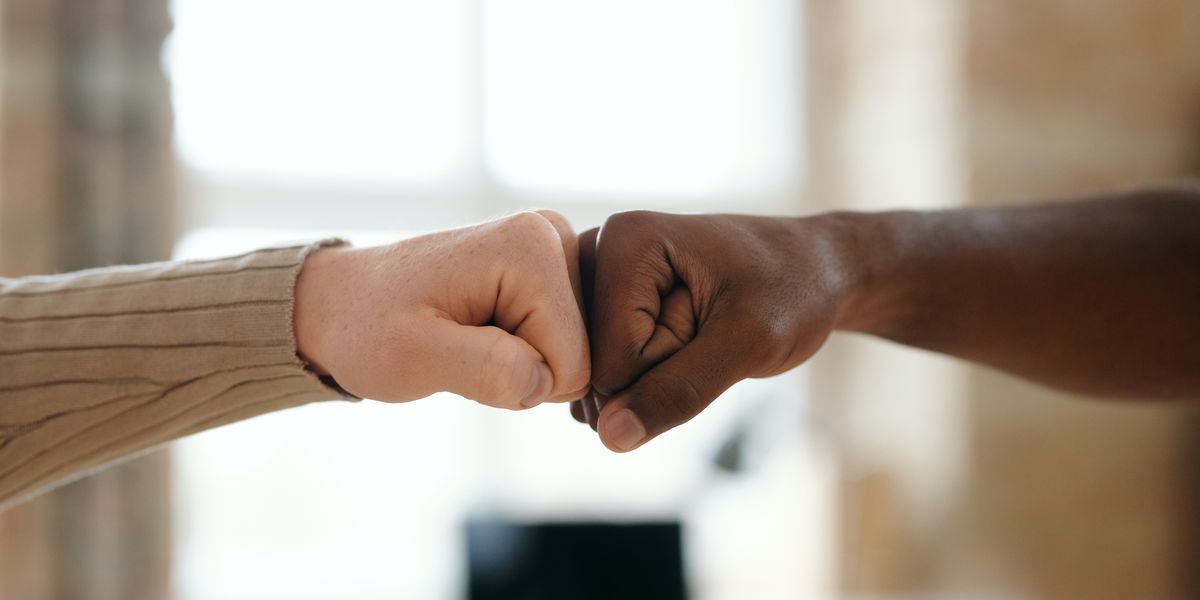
[{"xmin": 484, "ymin": 0, "xmax": 799, "ymax": 196}]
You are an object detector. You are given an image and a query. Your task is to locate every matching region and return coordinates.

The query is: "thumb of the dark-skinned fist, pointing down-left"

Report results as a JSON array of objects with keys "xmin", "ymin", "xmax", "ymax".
[{"xmin": 599, "ymin": 323, "xmax": 750, "ymax": 452}]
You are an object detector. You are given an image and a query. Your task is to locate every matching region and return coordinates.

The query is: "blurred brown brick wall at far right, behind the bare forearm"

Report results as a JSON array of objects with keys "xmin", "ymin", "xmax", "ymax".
[{"xmin": 965, "ymin": 0, "xmax": 1200, "ymax": 599}]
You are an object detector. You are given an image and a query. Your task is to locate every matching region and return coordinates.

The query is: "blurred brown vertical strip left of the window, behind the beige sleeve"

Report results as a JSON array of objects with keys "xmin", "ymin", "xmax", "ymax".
[{"xmin": 0, "ymin": 0, "xmax": 175, "ymax": 600}]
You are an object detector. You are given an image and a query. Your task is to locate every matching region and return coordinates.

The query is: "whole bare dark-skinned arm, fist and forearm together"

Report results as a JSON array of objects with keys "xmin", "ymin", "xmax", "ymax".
[{"xmin": 572, "ymin": 185, "xmax": 1200, "ymax": 451}]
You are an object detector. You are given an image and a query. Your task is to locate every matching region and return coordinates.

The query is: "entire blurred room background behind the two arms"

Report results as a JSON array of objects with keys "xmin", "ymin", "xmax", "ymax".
[{"xmin": 0, "ymin": 0, "xmax": 1200, "ymax": 600}]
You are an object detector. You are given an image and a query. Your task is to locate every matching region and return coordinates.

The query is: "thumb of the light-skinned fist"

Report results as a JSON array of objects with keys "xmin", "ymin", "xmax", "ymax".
[{"xmin": 424, "ymin": 319, "xmax": 554, "ymax": 410}]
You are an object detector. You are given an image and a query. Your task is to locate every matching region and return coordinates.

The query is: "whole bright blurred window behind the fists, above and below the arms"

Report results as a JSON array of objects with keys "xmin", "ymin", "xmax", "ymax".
[{"xmin": 164, "ymin": 0, "xmax": 832, "ymax": 600}]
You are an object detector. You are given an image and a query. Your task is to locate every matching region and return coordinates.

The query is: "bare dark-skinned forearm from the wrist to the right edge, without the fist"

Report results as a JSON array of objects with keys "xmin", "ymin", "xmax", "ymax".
[{"xmin": 817, "ymin": 185, "xmax": 1200, "ymax": 398}]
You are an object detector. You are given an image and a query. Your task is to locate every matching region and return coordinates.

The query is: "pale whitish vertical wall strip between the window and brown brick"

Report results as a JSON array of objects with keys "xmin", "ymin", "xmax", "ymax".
[{"xmin": 808, "ymin": 0, "xmax": 968, "ymax": 590}]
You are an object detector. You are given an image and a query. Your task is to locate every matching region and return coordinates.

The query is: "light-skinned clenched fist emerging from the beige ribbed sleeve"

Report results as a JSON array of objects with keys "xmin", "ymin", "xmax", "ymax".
[{"xmin": 294, "ymin": 211, "xmax": 590, "ymax": 409}]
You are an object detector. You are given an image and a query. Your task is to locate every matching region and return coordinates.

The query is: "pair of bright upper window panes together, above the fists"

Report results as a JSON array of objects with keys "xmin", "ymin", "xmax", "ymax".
[{"xmin": 167, "ymin": 0, "xmax": 800, "ymax": 202}]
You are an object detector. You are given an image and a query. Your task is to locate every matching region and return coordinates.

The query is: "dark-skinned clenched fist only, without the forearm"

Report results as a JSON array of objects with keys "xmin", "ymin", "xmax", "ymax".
[{"xmin": 571, "ymin": 211, "xmax": 846, "ymax": 451}]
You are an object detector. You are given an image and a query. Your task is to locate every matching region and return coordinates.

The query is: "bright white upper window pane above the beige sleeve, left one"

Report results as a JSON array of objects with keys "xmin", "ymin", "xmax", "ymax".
[{"xmin": 167, "ymin": 0, "xmax": 463, "ymax": 181}]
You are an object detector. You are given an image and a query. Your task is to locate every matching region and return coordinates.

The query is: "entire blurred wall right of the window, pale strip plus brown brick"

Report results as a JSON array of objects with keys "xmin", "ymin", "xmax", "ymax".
[{"xmin": 809, "ymin": 0, "xmax": 1200, "ymax": 599}]
